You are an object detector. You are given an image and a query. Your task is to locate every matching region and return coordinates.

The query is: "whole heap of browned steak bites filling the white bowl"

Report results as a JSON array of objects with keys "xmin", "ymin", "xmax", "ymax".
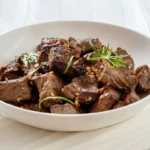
[{"xmin": 0, "ymin": 37, "xmax": 150, "ymax": 114}]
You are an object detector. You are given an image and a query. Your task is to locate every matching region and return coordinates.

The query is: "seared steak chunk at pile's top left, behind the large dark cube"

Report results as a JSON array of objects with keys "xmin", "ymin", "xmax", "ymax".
[{"xmin": 37, "ymin": 38, "xmax": 67, "ymax": 62}]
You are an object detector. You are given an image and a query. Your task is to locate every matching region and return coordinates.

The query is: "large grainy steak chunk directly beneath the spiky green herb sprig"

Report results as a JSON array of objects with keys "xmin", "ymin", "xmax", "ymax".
[{"xmin": 94, "ymin": 60, "xmax": 137, "ymax": 92}]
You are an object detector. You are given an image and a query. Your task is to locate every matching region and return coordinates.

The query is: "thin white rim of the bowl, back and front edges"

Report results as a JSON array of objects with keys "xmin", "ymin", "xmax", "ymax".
[{"xmin": 0, "ymin": 20, "xmax": 150, "ymax": 117}]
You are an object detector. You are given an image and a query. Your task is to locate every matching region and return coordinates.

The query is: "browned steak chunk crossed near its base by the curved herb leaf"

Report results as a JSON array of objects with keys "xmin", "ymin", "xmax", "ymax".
[{"xmin": 33, "ymin": 72, "xmax": 64, "ymax": 108}]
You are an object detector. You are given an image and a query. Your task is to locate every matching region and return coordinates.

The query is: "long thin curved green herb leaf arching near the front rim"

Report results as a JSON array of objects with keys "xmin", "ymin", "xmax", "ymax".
[{"xmin": 39, "ymin": 96, "xmax": 74, "ymax": 109}]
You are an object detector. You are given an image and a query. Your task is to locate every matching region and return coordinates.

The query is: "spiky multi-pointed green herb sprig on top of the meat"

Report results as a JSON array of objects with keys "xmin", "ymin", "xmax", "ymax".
[{"xmin": 87, "ymin": 42, "xmax": 129, "ymax": 67}]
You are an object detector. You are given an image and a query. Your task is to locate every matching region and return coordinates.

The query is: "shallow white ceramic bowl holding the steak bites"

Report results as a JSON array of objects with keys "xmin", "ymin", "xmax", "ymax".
[{"xmin": 0, "ymin": 21, "xmax": 150, "ymax": 131}]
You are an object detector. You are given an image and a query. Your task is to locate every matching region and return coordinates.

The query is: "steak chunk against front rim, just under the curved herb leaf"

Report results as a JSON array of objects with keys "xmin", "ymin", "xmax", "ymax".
[{"xmin": 50, "ymin": 103, "xmax": 80, "ymax": 114}]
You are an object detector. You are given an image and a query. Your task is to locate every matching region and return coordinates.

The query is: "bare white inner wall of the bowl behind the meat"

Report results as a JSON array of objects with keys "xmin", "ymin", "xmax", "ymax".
[{"xmin": 0, "ymin": 22, "xmax": 150, "ymax": 66}]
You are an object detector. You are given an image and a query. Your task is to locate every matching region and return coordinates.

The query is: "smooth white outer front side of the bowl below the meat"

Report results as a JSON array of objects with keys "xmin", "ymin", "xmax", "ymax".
[{"xmin": 0, "ymin": 97, "xmax": 150, "ymax": 131}]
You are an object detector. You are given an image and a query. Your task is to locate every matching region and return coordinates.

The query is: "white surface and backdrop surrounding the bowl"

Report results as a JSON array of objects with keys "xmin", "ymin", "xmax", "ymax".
[{"xmin": 0, "ymin": 0, "xmax": 150, "ymax": 150}]
